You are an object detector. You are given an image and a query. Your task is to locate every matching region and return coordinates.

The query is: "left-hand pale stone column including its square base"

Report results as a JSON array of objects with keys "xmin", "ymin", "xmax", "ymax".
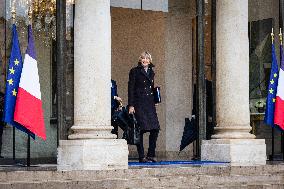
[{"xmin": 58, "ymin": 0, "xmax": 128, "ymax": 170}]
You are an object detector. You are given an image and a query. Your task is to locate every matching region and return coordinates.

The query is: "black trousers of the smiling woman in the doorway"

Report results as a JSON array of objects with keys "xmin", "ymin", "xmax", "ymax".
[{"xmin": 136, "ymin": 129, "xmax": 159, "ymax": 159}]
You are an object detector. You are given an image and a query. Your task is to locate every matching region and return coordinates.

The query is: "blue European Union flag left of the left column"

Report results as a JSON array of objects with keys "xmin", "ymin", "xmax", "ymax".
[{"xmin": 3, "ymin": 24, "xmax": 35, "ymax": 138}]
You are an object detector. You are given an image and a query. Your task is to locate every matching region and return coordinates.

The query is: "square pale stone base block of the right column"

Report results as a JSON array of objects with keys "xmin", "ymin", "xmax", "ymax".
[{"xmin": 201, "ymin": 139, "xmax": 266, "ymax": 166}]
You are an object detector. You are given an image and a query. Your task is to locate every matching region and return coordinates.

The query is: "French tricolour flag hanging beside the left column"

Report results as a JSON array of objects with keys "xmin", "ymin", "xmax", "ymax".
[{"xmin": 14, "ymin": 25, "xmax": 46, "ymax": 140}]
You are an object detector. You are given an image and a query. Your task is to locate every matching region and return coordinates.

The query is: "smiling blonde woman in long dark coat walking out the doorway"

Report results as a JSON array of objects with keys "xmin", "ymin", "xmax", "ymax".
[{"xmin": 128, "ymin": 51, "xmax": 160, "ymax": 162}]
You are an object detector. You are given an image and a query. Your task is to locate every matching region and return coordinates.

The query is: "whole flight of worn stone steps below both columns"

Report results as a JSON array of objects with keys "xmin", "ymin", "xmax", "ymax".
[{"xmin": 0, "ymin": 164, "xmax": 284, "ymax": 189}]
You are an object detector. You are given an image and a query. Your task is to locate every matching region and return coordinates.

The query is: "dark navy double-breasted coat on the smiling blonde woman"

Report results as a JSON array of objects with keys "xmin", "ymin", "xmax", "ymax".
[{"xmin": 128, "ymin": 63, "xmax": 160, "ymax": 131}]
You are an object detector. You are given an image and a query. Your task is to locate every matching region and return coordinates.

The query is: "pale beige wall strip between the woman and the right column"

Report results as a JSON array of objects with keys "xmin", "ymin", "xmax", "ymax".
[{"xmin": 165, "ymin": 0, "xmax": 192, "ymax": 158}]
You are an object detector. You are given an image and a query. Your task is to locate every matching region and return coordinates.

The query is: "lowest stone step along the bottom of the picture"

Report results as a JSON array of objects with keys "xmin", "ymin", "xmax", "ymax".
[{"xmin": 0, "ymin": 174, "xmax": 284, "ymax": 189}]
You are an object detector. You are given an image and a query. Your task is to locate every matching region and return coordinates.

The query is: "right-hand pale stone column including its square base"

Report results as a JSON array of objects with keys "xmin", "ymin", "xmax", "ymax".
[{"xmin": 201, "ymin": 0, "xmax": 266, "ymax": 165}]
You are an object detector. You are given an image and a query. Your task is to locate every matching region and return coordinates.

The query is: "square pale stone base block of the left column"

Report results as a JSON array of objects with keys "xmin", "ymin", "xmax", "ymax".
[{"xmin": 57, "ymin": 139, "xmax": 128, "ymax": 171}]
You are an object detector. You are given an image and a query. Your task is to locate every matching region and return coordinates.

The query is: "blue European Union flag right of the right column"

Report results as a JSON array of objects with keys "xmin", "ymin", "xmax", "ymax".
[{"xmin": 264, "ymin": 44, "xmax": 278, "ymax": 127}]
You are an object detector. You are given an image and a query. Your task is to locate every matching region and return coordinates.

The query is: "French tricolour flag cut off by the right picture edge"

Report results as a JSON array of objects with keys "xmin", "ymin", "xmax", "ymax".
[{"xmin": 274, "ymin": 45, "xmax": 284, "ymax": 130}]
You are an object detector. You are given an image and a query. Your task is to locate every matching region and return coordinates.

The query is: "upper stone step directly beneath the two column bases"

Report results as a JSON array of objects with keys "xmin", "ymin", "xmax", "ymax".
[{"xmin": 0, "ymin": 165, "xmax": 284, "ymax": 182}]
